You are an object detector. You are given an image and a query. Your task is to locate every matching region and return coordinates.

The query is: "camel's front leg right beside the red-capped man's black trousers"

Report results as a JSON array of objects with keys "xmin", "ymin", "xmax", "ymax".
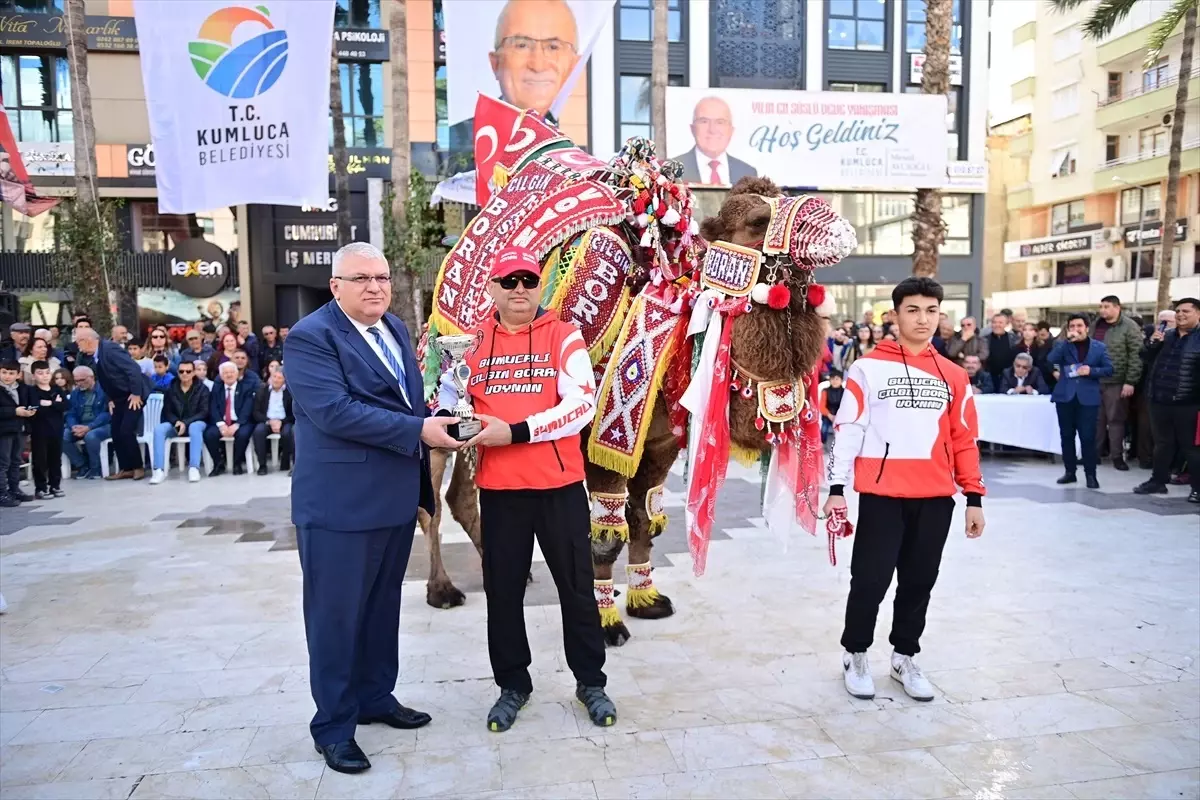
[{"xmin": 583, "ymin": 453, "xmax": 629, "ymax": 648}]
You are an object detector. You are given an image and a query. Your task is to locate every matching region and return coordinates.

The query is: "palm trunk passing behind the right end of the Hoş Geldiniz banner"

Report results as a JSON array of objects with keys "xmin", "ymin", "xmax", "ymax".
[{"xmin": 912, "ymin": 0, "xmax": 953, "ymax": 277}]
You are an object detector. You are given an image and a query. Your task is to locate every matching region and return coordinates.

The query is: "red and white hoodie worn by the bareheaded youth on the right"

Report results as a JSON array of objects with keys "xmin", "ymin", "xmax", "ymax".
[{"xmin": 829, "ymin": 339, "xmax": 986, "ymax": 505}]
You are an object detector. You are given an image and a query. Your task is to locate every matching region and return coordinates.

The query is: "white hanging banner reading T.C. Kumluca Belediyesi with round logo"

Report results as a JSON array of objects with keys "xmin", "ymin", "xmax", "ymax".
[{"xmin": 133, "ymin": 0, "xmax": 334, "ymax": 213}]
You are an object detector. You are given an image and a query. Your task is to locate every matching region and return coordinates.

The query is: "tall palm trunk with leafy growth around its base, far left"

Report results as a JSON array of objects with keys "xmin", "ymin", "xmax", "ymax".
[{"xmin": 62, "ymin": 0, "xmax": 113, "ymax": 335}]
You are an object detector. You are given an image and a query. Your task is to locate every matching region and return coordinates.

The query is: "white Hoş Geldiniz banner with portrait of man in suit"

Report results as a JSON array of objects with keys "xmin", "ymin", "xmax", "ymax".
[{"xmin": 667, "ymin": 86, "xmax": 947, "ymax": 190}]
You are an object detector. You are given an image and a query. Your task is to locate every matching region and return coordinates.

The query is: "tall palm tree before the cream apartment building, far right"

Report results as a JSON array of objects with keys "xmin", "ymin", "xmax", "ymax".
[{"xmin": 1050, "ymin": 0, "xmax": 1198, "ymax": 311}]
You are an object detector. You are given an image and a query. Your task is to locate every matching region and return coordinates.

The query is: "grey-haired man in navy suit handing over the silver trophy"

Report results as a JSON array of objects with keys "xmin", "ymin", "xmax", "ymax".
[{"xmin": 283, "ymin": 242, "xmax": 458, "ymax": 772}]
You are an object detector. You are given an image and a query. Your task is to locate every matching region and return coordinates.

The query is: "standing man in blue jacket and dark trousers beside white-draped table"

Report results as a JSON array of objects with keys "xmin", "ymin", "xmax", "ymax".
[{"xmin": 1046, "ymin": 314, "xmax": 1112, "ymax": 489}]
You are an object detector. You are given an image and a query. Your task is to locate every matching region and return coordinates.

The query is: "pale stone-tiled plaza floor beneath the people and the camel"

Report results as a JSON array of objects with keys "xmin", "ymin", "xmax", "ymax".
[{"xmin": 0, "ymin": 459, "xmax": 1200, "ymax": 800}]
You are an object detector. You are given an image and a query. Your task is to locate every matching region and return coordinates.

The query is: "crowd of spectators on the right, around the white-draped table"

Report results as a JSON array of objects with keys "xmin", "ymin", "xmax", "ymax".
[{"xmin": 821, "ymin": 295, "xmax": 1200, "ymax": 503}]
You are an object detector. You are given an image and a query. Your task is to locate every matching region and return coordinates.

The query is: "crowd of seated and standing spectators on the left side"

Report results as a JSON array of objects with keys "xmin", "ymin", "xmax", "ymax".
[{"xmin": 0, "ymin": 317, "xmax": 294, "ymax": 507}]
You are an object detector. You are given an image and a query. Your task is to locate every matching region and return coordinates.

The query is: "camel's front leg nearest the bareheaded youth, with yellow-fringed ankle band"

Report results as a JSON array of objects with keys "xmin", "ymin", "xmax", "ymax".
[{"xmin": 625, "ymin": 396, "xmax": 679, "ymax": 619}]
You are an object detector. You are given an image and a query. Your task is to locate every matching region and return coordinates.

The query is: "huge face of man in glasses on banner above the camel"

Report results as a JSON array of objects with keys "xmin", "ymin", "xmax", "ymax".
[{"xmin": 487, "ymin": 0, "xmax": 580, "ymax": 115}]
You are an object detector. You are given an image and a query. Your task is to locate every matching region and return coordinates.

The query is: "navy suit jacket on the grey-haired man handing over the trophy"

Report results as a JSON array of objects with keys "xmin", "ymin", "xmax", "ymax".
[{"xmin": 283, "ymin": 301, "xmax": 434, "ymax": 531}]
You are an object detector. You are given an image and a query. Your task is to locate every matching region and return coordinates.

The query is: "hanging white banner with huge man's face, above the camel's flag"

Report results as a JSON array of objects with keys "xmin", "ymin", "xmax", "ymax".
[{"xmin": 443, "ymin": 0, "xmax": 613, "ymax": 125}]
